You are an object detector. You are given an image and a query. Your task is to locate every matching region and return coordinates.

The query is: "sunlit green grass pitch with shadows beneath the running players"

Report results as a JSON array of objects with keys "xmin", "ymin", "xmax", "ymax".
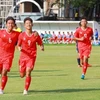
[{"xmin": 0, "ymin": 45, "xmax": 100, "ymax": 100}]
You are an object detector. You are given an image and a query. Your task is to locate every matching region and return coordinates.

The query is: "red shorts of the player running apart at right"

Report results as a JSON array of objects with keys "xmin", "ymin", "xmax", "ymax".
[{"xmin": 79, "ymin": 47, "xmax": 91, "ymax": 59}]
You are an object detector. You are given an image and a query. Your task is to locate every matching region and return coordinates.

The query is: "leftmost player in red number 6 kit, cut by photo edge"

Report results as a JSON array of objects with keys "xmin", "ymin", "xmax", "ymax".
[{"xmin": 0, "ymin": 17, "xmax": 19, "ymax": 94}]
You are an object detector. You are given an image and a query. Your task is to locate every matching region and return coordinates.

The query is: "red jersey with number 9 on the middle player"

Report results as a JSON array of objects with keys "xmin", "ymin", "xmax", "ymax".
[{"xmin": 18, "ymin": 32, "xmax": 42, "ymax": 58}]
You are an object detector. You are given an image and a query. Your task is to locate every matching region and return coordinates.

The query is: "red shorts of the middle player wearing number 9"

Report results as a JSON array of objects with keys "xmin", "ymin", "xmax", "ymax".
[{"xmin": 19, "ymin": 57, "xmax": 36, "ymax": 73}]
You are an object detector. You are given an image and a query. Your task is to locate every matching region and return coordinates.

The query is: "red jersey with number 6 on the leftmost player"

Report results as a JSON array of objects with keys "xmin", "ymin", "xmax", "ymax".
[{"xmin": 0, "ymin": 30, "xmax": 19, "ymax": 58}]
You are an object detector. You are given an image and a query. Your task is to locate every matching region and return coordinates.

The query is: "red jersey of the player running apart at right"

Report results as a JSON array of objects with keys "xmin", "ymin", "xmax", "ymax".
[{"xmin": 74, "ymin": 27, "xmax": 93, "ymax": 48}]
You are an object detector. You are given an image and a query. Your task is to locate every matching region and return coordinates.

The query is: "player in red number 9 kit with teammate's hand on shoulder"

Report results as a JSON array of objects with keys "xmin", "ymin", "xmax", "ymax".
[{"xmin": 18, "ymin": 17, "xmax": 44, "ymax": 95}]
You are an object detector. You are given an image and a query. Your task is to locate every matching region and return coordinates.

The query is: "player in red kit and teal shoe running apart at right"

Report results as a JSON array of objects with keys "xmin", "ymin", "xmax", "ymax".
[{"xmin": 74, "ymin": 17, "xmax": 93, "ymax": 79}]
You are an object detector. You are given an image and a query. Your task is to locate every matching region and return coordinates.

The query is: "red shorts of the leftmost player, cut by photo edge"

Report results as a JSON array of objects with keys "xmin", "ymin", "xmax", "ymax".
[{"xmin": 0, "ymin": 57, "xmax": 13, "ymax": 72}]
